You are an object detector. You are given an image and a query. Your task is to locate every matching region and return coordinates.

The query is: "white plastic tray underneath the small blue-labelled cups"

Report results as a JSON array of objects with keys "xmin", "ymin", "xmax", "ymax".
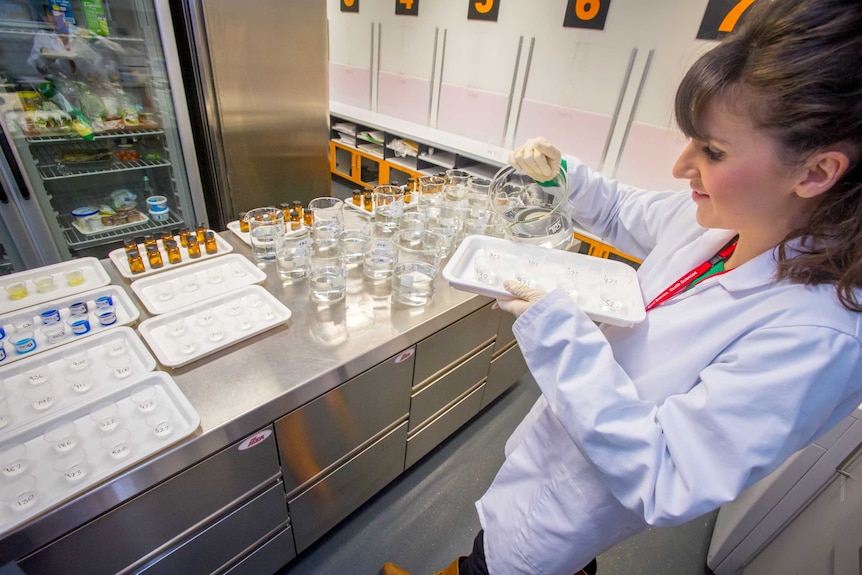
[{"xmin": 0, "ymin": 285, "xmax": 141, "ymax": 366}]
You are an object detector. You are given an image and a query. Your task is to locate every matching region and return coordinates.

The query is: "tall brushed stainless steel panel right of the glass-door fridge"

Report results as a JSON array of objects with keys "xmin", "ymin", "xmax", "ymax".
[{"xmin": 198, "ymin": 0, "xmax": 330, "ymax": 215}]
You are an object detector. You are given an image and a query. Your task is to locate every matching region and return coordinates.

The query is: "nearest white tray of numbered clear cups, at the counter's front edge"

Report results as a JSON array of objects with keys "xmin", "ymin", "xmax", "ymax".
[{"xmin": 0, "ymin": 371, "xmax": 200, "ymax": 536}]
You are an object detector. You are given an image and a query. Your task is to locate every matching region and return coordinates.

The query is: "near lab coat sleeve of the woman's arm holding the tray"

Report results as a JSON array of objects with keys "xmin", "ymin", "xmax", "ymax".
[{"xmin": 514, "ymin": 291, "xmax": 862, "ymax": 525}]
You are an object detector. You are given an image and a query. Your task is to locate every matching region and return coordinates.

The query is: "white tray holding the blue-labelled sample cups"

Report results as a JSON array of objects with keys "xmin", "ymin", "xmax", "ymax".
[{"xmin": 0, "ymin": 285, "xmax": 141, "ymax": 366}]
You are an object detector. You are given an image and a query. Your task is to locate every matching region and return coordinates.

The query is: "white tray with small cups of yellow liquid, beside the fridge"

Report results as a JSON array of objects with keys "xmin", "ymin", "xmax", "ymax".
[{"xmin": 0, "ymin": 257, "xmax": 111, "ymax": 314}]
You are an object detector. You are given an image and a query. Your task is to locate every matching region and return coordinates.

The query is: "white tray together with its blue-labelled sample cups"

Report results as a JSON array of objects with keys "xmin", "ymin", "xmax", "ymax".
[{"xmin": 0, "ymin": 285, "xmax": 141, "ymax": 367}]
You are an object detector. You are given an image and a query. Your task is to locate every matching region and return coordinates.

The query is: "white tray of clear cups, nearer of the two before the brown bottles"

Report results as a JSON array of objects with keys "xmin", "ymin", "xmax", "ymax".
[{"xmin": 138, "ymin": 285, "xmax": 291, "ymax": 367}]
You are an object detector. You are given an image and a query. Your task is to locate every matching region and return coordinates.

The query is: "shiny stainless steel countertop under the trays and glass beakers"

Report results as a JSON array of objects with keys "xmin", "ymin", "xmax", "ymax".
[{"xmin": 0, "ymin": 231, "xmax": 491, "ymax": 565}]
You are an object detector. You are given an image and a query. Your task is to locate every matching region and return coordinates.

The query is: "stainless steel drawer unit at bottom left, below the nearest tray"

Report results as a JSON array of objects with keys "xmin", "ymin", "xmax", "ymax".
[{"xmin": 19, "ymin": 428, "xmax": 286, "ymax": 575}]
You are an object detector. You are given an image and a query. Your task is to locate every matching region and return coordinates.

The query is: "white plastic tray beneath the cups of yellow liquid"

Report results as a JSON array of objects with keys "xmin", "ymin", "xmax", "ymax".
[{"xmin": 0, "ymin": 258, "xmax": 111, "ymax": 314}]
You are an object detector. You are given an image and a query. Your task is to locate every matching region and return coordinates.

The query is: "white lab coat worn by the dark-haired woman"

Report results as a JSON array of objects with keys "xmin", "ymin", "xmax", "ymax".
[{"xmin": 476, "ymin": 158, "xmax": 862, "ymax": 575}]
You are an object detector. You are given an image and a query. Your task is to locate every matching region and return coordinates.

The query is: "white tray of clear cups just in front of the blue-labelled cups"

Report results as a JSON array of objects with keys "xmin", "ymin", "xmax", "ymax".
[{"xmin": 0, "ymin": 327, "xmax": 156, "ymax": 440}]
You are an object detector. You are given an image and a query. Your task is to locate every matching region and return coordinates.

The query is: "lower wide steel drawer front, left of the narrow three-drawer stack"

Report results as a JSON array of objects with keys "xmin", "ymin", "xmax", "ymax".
[{"xmin": 288, "ymin": 421, "xmax": 407, "ymax": 553}]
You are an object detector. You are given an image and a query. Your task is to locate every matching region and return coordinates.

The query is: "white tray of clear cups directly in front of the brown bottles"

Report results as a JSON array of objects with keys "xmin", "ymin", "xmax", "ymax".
[{"xmin": 132, "ymin": 254, "xmax": 266, "ymax": 315}]
